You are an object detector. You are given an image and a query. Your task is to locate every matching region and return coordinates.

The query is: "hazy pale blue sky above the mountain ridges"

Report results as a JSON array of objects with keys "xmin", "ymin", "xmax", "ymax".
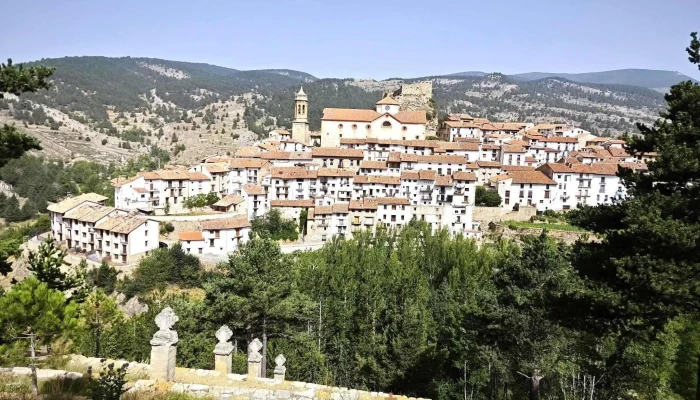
[{"xmin": 0, "ymin": 0, "xmax": 700, "ymax": 78}]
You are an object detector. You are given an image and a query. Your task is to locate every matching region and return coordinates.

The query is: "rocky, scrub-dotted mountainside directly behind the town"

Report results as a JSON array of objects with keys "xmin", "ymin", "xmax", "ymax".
[{"xmin": 0, "ymin": 57, "xmax": 668, "ymax": 164}]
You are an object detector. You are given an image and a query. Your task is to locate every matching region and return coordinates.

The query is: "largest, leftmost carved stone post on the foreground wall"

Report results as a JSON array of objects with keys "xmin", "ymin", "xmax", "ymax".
[{"xmin": 151, "ymin": 307, "xmax": 179, "ymax": 381}]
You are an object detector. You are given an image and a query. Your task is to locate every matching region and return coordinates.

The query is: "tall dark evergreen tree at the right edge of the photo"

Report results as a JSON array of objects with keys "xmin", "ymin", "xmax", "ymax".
[{"xmin": 567, "ymin": 33, "xmax": 700, "ymax": 398}]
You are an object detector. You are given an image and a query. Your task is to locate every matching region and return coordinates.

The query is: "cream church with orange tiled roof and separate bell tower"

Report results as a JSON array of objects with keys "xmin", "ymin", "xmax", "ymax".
[{"xmin": 292, "ymin": 88, "xmax": 427, "ymax": 147}]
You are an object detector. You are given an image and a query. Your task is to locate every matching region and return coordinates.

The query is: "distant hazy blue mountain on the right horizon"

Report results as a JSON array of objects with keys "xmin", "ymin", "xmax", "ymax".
[{"xmin": 510, "ymin": 69, "xmax": 695, "ymax": 89}]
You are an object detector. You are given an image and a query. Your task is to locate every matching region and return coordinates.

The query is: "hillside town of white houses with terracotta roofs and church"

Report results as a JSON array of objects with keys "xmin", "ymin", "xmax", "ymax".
[{"xmin": 49, "ymin": 88, "xmax": 655, "ymax": 263}]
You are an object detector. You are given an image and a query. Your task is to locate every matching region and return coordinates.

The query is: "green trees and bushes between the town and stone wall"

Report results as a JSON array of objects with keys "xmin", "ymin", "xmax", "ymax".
[{"xmin": 0, "ymin": 222, "xmax": 700, "ymax": 399}]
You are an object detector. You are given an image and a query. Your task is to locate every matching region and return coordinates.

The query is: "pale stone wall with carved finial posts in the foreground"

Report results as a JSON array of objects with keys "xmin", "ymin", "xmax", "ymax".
[{"xmin": 0, "ymin": 307, "xmax": 424, "ymax": 400}]
